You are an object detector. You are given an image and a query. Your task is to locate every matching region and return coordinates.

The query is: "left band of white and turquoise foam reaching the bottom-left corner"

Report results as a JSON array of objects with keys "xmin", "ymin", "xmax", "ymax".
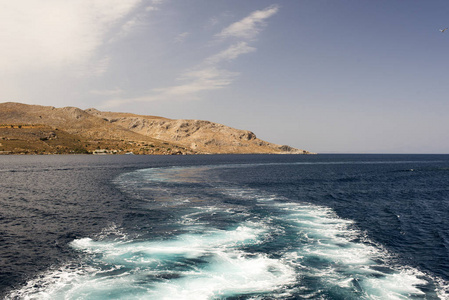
[{"xmin": 11, "ymin": 222, "xmax": 296, "ymax": 299}]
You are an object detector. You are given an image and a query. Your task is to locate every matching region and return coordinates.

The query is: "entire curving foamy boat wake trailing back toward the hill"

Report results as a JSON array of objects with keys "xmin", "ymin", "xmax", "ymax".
[{"xmin": 10, "ymin": 167, "xmax": 447, "ymax": 299}]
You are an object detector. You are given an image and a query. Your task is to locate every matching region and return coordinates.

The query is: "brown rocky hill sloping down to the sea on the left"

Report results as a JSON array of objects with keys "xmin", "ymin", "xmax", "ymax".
[{"xmin": 0, "ymin": 102, "xmax": 309, "ymax": 154}]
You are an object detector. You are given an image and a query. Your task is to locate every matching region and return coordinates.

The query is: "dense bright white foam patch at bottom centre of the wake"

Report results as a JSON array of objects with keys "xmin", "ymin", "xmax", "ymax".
[{"xmin": 138, "ymin": 252, "xmax": 296, "ymax": 299}]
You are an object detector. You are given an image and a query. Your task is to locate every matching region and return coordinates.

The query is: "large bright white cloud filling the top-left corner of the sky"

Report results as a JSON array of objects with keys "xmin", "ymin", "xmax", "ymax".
[{"xmin": 0, "ymin": 0, "xmax": 141, "ymax": 73}]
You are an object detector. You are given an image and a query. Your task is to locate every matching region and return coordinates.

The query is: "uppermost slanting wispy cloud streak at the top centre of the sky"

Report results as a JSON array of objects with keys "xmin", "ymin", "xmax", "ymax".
[{"xmin": 216, "ymin": 5, "xmax": 279, "ymax": 39}]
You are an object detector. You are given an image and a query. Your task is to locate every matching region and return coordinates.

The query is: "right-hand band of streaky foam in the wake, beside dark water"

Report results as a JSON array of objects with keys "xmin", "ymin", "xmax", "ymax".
[{"xmin": 219, "ymin": 189, "xmax": 436, "ymax": 299}]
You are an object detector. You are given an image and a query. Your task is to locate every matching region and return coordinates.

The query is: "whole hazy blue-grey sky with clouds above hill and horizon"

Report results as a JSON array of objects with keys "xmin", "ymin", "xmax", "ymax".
[{"xmin": 0, "ymin": 0, "xmax": 449, "ymax": 153}]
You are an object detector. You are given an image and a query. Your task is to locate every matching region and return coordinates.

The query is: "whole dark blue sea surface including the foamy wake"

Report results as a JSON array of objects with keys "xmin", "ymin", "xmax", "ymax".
[{"xmin": 0, "ymin": 155, "xmax": 449, "ymax": 300}]
